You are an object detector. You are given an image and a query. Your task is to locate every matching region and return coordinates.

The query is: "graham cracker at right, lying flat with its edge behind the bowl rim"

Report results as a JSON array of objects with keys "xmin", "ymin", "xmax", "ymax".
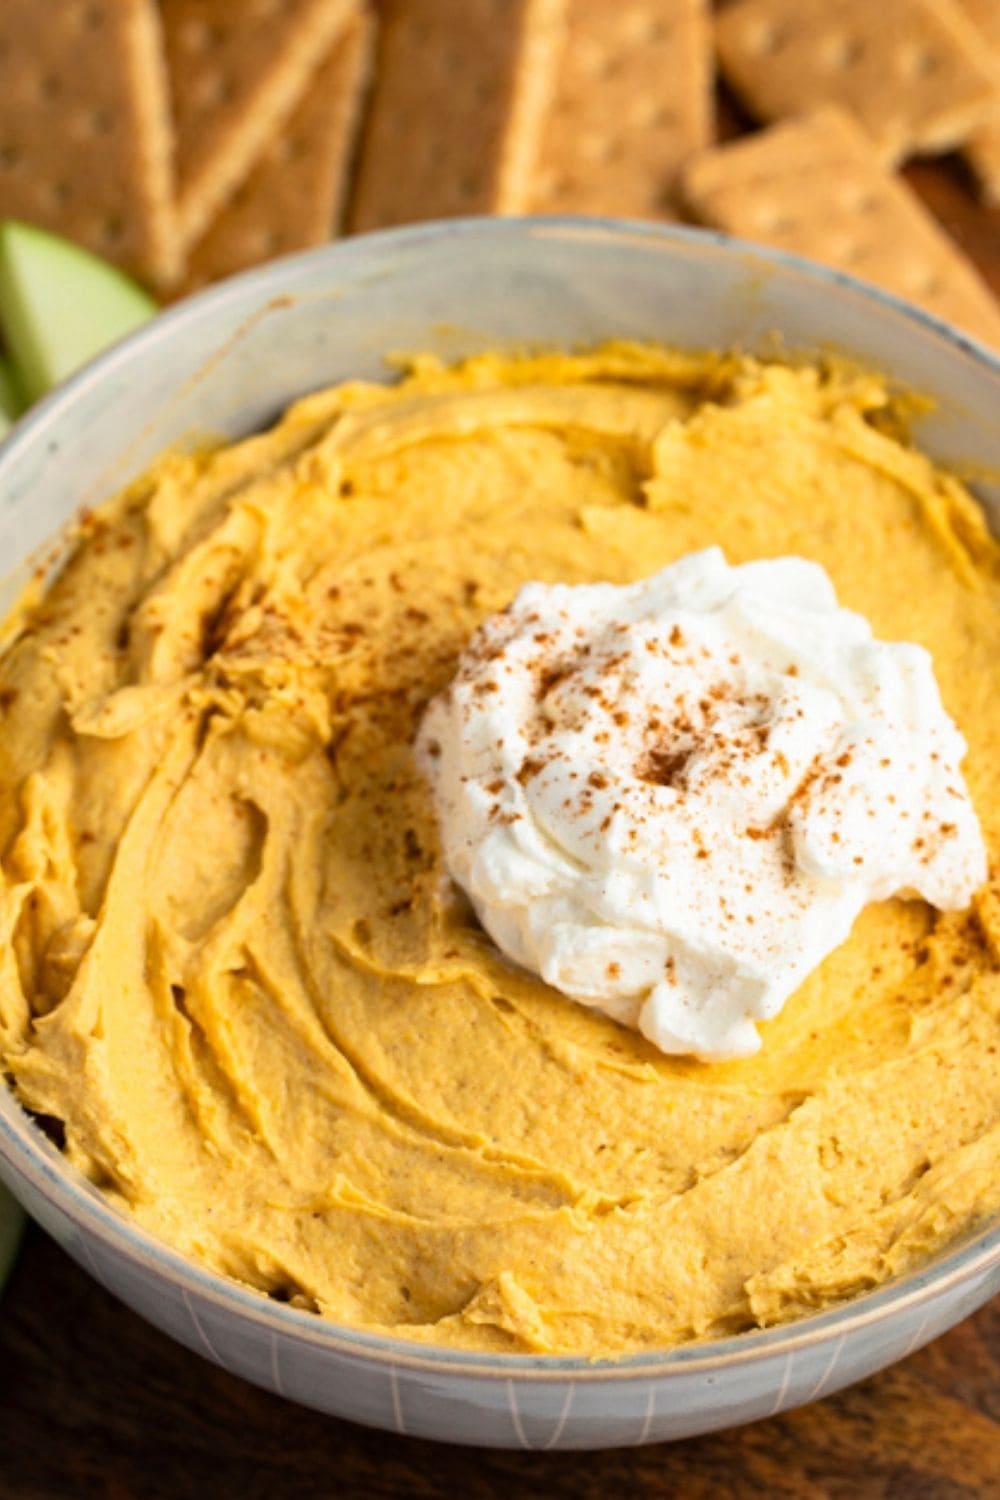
[{"xmin": 682, "ymin": 105, "xmax": 1000, "ymax": 348}]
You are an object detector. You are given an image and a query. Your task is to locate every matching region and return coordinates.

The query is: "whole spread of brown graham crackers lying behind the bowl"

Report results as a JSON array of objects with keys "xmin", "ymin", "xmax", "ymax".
[{"xmin": 0, "ymin": 0, "xmax": 1000, "ymax": 347}]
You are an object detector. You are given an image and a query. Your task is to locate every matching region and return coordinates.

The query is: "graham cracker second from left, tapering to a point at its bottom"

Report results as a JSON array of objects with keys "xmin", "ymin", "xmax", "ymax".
[{"xmin": 160, "ymin": 0, "xmax": 358, "ymax": 248}]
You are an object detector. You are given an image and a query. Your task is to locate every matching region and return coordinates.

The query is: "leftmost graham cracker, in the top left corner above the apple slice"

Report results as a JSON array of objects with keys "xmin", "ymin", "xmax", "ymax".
[{"xmin": 0, "ymin": 0, "xmax": 178, "ymax": 287}]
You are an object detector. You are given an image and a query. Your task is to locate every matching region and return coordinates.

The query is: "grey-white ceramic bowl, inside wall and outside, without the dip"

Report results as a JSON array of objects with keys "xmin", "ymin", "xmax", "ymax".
[{"xmin": 0, "ymin": 219, "xmax": 1000, "ymax": 1449}]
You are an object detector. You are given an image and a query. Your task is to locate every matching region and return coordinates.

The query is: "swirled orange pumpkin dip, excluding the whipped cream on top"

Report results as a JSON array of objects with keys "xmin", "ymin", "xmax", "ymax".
[{"xmin": 0, "ymin": 345, "xmax": 1000, "ymax": 1355}]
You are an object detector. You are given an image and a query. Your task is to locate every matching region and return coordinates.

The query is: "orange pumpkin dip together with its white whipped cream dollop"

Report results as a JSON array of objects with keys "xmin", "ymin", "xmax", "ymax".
[{"xmin": 0, "ymin": 344, "xmax": 1000, "ymax": 1358}]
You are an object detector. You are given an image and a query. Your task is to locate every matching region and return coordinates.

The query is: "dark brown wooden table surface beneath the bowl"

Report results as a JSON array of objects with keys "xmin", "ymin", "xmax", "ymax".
[{"xmin": 0, "ymin": 126, "xmax": 1000, "ymax": 1500}]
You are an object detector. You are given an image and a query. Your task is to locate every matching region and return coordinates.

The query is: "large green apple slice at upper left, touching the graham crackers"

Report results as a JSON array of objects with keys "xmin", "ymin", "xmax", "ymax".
[{"xmin": 0, "ymin": 219, "xmax": 156, "ymax": 401}]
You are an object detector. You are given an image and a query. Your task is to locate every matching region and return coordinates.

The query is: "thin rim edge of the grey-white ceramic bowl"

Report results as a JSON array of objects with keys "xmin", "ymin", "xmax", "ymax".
[{"xmin": 0, "ymin": 215, "xmax": 1000, "ymax": 1383}]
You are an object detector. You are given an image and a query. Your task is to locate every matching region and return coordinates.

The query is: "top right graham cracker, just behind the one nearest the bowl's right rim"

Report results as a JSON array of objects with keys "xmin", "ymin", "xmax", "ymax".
[{"xmin": 715, "ymin": 0, "xmax": 997, "ymax": 164}]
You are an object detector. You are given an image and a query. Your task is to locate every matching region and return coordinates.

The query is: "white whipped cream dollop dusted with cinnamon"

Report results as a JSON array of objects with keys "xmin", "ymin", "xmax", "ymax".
[{"xmin": 417, "ymin": 548, "xmax": 987, "ymax": 1059}]
